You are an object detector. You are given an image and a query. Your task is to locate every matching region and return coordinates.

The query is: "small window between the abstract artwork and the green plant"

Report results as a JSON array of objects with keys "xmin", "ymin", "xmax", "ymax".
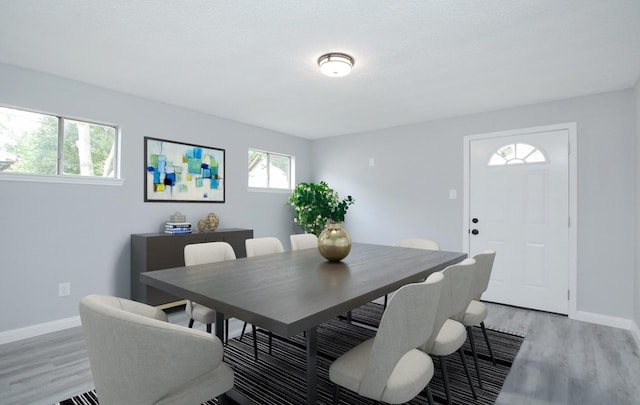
[{"xmin": 249, "ymin": 149, "xmax": 294, "ymax": 190}]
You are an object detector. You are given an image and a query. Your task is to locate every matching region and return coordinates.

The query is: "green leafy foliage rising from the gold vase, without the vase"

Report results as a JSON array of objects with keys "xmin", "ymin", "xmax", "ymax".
[{"xmin": 287, "ymin": 181, "xmax": 355, "ymax": 236}]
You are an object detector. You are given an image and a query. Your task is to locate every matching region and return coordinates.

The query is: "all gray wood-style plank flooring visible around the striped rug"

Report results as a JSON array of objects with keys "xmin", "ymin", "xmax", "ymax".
[{"xmin": 0, "ymin": 304, "xmax": 640, "ymax": 405}]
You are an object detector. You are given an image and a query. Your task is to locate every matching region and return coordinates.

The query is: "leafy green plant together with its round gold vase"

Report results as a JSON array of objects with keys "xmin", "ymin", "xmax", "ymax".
[{"xmin": 287, "ymin": 181, "xmax": 355, "ymax": 261}]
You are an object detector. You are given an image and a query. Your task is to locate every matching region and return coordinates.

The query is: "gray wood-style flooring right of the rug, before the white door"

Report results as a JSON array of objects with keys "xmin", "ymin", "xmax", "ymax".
[{"xmin": 485, "ymin": 304, "xmax": 640, "ymax": 405}]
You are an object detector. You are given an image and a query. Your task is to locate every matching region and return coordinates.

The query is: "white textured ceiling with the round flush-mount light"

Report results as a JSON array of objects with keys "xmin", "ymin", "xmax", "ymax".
[{"xmin": 0, "ymin": 0, "xmax": 640, "ymax": 139}]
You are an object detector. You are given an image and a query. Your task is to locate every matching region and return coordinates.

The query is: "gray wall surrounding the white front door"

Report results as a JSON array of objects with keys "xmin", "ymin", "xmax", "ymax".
[{"xmin": 312, "ymin": 90, "xmax": 636, "ymax": 319}]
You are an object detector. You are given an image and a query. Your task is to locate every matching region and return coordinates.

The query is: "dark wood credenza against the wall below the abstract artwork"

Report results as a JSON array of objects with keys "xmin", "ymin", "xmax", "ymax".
[{"xmin": 131, "ymin": 228, "xmax": 253, "ymax": 307}]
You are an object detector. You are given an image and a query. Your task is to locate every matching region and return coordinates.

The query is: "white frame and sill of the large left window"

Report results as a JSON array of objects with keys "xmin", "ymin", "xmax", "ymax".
[{"xmin": 0, "ymin": 103, "xmax": 124, "ymax": 186}]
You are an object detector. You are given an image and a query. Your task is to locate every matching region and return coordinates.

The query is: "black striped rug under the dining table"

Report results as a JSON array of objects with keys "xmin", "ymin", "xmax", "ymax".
[{"xmin": 55, "ymin": 303, "xmax": 524, "ymax": 405}]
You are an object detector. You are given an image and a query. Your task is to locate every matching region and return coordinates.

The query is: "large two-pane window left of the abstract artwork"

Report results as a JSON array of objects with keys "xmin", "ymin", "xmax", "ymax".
[{"xmin": 0, "ymin": 107, "xmax": 119, "ymax": 179}]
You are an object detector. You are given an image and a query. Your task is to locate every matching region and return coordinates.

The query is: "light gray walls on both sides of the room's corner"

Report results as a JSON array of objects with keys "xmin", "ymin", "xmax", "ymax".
[{"xmin": 0, "ymin": 60, "xmax": 640, "ymax": 332}]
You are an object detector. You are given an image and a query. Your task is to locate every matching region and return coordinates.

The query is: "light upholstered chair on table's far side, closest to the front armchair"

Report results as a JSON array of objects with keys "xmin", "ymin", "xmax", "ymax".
[{"xmin": 184, "ymin": 242, "xmax": 236, "ymax": 343}]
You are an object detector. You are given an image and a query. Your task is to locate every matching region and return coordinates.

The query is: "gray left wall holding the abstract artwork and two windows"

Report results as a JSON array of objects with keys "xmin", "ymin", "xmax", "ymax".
[{"xmin": 0, "ymin": 64, "xmax": 311, "ymax": 331}]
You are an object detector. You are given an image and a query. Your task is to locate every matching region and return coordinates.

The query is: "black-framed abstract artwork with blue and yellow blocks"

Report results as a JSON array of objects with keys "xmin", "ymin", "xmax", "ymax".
[{"xmin": 144, "ymin": 137, "xmax": 225, "ymax": 203}]
